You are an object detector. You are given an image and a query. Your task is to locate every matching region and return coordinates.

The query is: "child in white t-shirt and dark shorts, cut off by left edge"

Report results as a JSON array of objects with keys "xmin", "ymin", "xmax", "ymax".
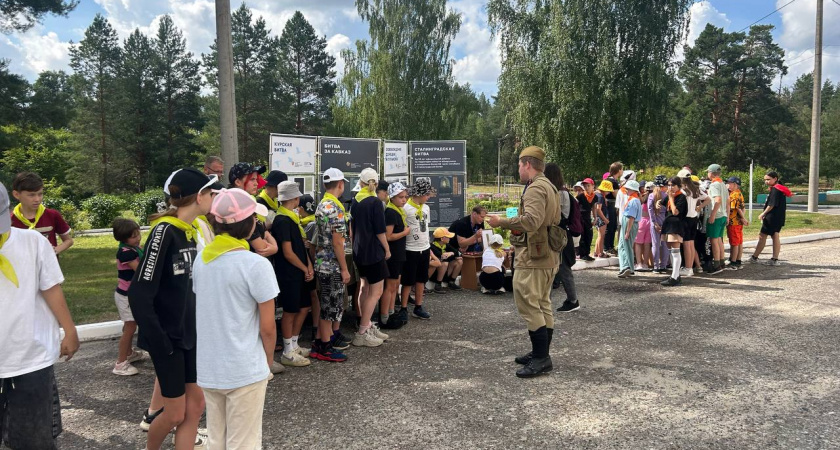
[{"xmin": 0, "ymin": 183, "xmax": 79, "ymax": 449}]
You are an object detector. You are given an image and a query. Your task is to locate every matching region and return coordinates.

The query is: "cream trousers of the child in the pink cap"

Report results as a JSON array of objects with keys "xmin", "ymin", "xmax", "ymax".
[{"xmin": 203, "ymin": 378, "xmax": 268, "ymax": 450}]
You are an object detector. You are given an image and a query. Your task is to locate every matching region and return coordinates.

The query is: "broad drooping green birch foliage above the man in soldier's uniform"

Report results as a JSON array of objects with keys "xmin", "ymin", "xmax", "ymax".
[{"xmin": 487, "ymin": 0, "xmax": 693, "ymax": 174}]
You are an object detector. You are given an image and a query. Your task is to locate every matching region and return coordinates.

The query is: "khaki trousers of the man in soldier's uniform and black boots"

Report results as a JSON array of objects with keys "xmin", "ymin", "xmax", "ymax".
[{"xmin": 513, "ymin": 267, "xmax": 557, "ymax": 331}]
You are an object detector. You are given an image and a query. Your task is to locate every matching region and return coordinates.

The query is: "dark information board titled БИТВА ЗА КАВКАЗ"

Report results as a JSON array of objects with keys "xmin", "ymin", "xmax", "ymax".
[{"xmin": 318, "ymin": 137, "xmax": 379, "ymax": 173}]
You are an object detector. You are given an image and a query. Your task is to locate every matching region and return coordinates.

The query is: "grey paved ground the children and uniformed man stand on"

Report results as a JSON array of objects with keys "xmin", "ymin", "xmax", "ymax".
[{"xmin": 50, "ymin": 240, "xmax": 840, "ymax": 449}]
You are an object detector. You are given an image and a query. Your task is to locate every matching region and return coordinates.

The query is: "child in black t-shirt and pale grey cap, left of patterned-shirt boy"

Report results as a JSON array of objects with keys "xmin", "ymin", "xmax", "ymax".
[{"xmin": 271, "ymin": 181, "xmax": 315, "ymax": 367}]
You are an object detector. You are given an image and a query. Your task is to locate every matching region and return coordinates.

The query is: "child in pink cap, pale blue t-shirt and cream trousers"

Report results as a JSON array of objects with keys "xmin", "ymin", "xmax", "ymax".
[{"xmin": 193, "ymin": 189, "xmax": 280, "ymax": 448}]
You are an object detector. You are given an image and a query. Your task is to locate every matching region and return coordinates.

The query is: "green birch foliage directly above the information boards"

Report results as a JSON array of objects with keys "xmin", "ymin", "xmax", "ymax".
[{"xmin": 332, "ymin": 0, "xmax": 461, "ymax": 140}]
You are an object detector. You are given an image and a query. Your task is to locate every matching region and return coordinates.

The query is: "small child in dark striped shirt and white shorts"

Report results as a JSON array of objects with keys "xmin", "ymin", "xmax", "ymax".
[{"xmin": 112, "ymin": 217, "xmax": 149, "ymax": 375}]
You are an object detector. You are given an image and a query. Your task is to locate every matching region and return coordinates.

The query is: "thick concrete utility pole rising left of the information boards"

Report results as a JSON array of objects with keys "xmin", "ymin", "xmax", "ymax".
[{"xmin": 216, "ymin": 0, "xmax": 239, "ymax": 168}]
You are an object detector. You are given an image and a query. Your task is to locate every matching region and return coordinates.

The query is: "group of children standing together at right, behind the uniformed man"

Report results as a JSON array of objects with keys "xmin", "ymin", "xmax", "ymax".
[{"xmin": 574, "ymin": 162, "xmax": 792, "ymax": 286}]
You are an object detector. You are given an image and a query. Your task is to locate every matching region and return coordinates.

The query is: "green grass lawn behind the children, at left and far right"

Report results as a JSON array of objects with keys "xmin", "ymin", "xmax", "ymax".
[{"xmin": 61, "ymin": 211, "xmax": 840, "ymax": 324}]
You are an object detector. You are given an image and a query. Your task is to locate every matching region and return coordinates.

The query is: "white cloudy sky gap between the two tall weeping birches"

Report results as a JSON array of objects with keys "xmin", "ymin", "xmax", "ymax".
[{"xmin": 450, "ymin": 0, "xmax": 502, "ymax": 94}]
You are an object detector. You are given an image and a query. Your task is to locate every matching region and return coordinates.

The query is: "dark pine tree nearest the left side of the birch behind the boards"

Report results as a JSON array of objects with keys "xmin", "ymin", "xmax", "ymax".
[{"xmin": 279, "ymin": 11, "xmax": 336, "ymax": 135}]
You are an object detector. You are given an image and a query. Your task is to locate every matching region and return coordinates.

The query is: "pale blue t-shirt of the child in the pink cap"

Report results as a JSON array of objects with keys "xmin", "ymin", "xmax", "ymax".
[{"xmin": 193, "ymin": 251, "xmax": 280, "ymax": 389}]
